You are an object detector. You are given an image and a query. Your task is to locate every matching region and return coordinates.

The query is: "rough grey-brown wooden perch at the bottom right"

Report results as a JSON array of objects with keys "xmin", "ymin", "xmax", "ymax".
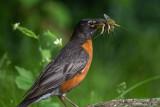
[{"xmin": 88, "ymin": 98, "xmax": 160, "ymax": 107}]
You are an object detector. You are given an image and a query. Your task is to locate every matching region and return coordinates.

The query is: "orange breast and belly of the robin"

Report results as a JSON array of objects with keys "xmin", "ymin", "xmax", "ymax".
[{"xmin": 60, "ymin": 39, "xmax": 93, "ymax": 93}]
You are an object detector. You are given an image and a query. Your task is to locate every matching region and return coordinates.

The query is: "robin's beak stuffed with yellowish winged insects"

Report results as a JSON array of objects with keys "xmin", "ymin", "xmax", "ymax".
[{"xmin": 92, "ymin": 14, "xmax": 120, "ymax": 34}]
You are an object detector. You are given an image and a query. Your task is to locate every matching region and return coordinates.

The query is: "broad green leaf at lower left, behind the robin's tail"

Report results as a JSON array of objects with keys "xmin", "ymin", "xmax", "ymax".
[{"xmin": 15, "ymin": 66, "xmax": 33, "ymax": 90}]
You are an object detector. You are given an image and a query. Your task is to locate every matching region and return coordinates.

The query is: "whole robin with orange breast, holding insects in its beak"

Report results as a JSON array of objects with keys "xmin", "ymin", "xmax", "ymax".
[{"xmin": 18, "ymin": 15, "xmax": 119, "ymax": 107}]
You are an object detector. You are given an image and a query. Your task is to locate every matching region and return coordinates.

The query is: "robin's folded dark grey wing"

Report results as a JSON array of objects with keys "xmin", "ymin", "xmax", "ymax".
[{"xmin": 23, "ymin": 44, "xmax": 89, "ymax": 99}]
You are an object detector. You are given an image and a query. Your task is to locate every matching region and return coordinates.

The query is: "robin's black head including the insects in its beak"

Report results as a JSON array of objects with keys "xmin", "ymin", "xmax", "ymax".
[{"xmin": 74, "ymin": 14, "xmax": 120, "ymax": 39}]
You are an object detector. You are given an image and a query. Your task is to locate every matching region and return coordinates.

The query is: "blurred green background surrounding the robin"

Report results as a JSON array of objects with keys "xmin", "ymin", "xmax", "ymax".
[{"xmin": 0, "ymin": 0, "xmax": 160, "ymax": 107}]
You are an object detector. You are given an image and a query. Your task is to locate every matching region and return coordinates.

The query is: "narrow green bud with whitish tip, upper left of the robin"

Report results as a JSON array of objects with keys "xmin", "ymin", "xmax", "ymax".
[{"xmin": 13, "ymin": 23, "xmax": 38, "ymax": 39}]
